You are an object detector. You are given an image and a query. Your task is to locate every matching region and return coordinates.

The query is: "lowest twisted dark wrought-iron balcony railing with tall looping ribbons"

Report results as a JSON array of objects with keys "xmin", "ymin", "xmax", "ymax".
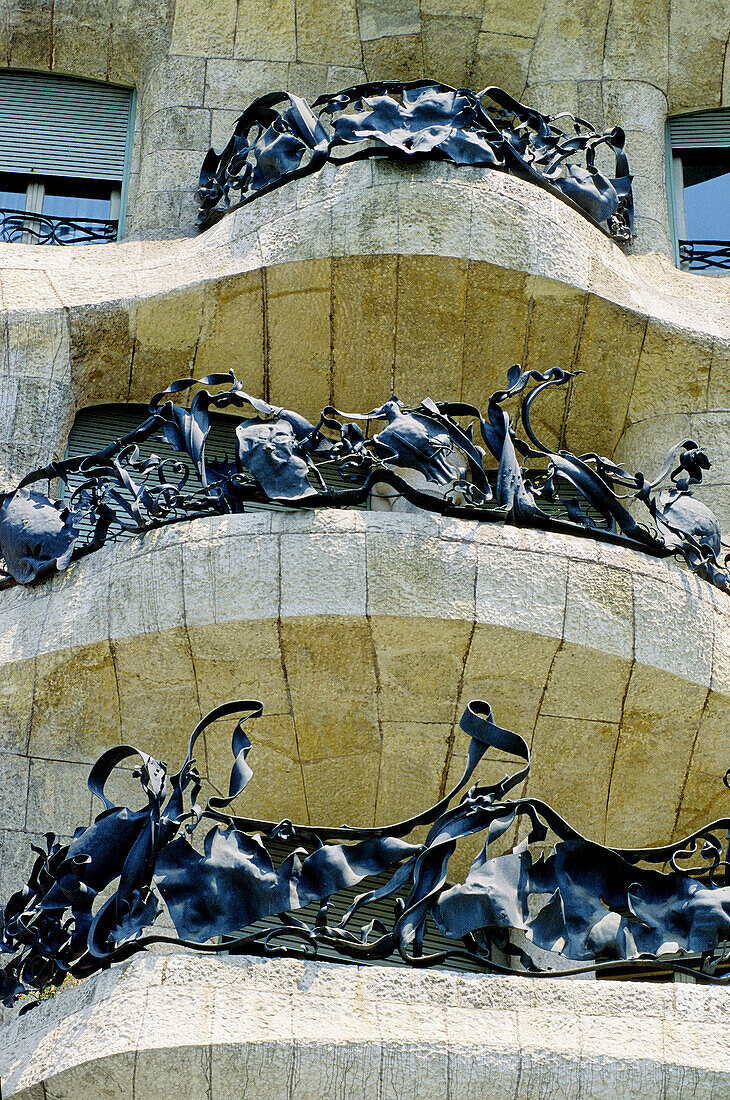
[{"xmin": 0, "ymin": 700, "xmax": 730, "ymax": 1003}]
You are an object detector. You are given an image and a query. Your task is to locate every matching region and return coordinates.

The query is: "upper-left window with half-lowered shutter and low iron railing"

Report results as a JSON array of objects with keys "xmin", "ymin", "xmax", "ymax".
[{"xmin": 0, "ymin": 69, "xmax": 134, "ymax": 244}]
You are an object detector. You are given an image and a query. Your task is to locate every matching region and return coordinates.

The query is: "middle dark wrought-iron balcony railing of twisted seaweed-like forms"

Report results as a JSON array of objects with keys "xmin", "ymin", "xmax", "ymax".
[{"xmin": 0, "ymin": 366, "xmax": 730, "ymax": 592}]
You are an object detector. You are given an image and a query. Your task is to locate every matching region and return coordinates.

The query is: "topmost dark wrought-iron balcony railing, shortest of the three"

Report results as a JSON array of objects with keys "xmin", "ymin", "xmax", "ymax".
[{"xmin": 197, "ymin": 80, "xmax": 633, "ymax": 242}]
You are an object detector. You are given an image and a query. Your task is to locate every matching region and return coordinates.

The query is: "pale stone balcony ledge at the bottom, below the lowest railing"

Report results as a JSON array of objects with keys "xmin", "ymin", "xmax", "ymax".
[{"xmin": 0, "ymin": 955, "xmax": 730, "ymax": 1100}]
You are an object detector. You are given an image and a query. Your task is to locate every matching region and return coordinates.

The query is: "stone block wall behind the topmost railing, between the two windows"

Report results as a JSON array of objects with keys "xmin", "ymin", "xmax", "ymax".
[{"xmin": 0, "ymin": 0, "xmax": 730, "ymax": 248}]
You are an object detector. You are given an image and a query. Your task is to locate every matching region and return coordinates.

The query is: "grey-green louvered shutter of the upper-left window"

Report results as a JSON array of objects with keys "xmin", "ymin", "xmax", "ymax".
[{"xmin": 0, "ymin": 69, "xmax": 133, "ymax": 180}]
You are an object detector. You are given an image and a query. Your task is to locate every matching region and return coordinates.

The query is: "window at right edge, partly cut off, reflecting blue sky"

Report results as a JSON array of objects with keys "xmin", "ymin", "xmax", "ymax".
[{"xmin": 666, "ymin": 110, "xmax": 730, "ymax": 274}]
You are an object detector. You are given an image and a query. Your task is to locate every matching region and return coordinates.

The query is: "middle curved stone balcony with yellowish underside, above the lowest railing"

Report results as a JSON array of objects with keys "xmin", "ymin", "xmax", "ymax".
[{"xmin": 0, "ymin": 510, "xmax": 730, "ymax": 897}]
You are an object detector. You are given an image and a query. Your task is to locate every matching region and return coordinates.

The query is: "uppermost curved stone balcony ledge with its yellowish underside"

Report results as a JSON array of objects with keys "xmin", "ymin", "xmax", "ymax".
[{"xmin": 0, "ymin": 163, "xmax": 730, "ymax": 485}]
